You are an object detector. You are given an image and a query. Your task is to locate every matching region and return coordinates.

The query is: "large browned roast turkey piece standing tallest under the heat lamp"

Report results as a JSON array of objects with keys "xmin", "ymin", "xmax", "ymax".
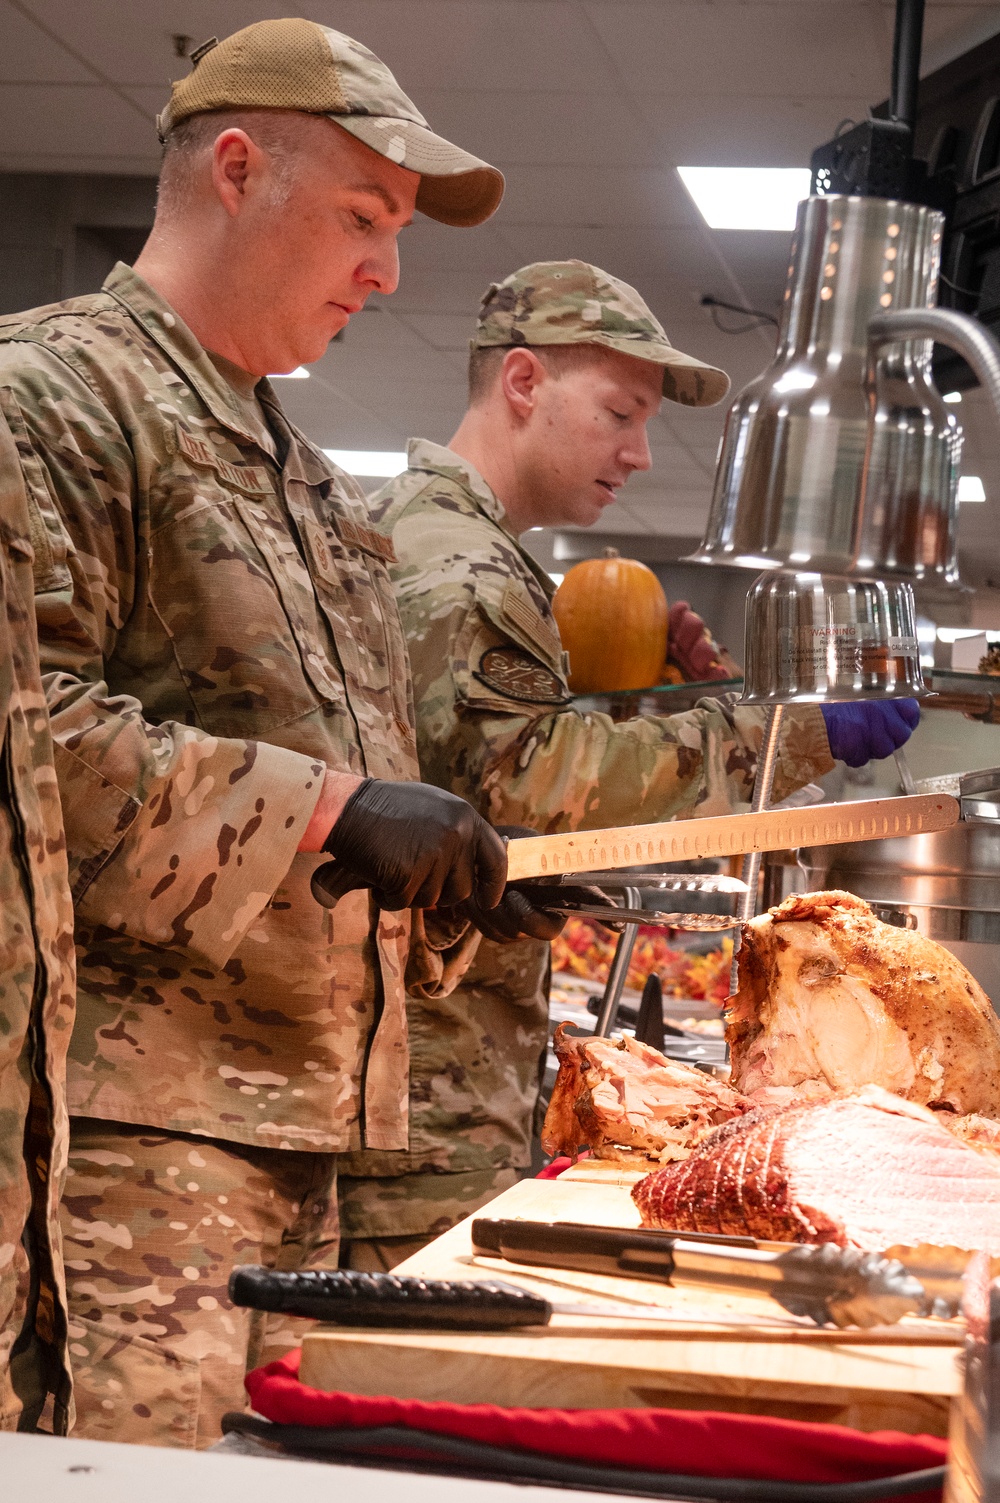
[{"xmin": 726, "ymin": 893, "xmax": 1000, "ymax": 1117}]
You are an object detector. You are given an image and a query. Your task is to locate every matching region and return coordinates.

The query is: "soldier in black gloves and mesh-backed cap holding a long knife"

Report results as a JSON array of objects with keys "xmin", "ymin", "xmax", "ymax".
[{"xmin": 0, "ymin": 21, "xmax": 529, "ymax": 1446}]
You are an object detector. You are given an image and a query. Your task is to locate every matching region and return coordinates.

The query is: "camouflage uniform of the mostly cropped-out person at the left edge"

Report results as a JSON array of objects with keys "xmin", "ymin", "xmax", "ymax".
[{"xmin": 0, "ymin": 424, "xmax": 75, "ymax": 1432}]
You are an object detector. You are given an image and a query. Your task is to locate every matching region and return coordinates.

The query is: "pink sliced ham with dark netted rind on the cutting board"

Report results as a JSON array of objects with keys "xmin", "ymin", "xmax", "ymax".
[{"xmin": 632, "ymin": 1087, "xmax": 1000, "ymax": 1252}]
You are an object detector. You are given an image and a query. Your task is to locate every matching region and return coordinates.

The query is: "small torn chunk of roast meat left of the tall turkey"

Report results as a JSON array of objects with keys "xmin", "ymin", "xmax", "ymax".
[{"xmin": 541, "ymin": 1024, "xmax": 747, "ymax": 1168}]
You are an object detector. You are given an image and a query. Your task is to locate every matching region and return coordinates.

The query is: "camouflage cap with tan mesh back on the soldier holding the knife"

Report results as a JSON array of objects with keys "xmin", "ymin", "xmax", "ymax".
[{"xmin": 156, "ymin": 18, "xmax": 504, "ymax": 225}]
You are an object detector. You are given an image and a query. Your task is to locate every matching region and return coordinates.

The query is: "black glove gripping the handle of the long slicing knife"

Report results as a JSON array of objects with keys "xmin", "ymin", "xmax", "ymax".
[{"xmin": 313, "ymin": 777, "xmax": 507, "ymax": 912}]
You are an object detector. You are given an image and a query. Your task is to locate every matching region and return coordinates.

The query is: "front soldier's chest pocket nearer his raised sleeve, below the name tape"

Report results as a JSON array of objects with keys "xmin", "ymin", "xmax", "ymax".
[{"xmin": 149, "ymin": 475, "xmax": 344, "ymax": 736}]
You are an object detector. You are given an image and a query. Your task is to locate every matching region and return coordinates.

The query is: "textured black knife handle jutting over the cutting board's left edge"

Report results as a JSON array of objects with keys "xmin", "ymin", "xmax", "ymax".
[{"xmin": 229, "ymin": 1264, "xmax": 552, "ymax": 1330}]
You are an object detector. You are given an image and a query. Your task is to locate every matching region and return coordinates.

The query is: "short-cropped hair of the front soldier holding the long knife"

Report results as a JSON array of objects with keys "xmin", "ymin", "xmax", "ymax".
[{"xmin": 156, "ymin": 110, "xmax": 329, "ymax": 213}]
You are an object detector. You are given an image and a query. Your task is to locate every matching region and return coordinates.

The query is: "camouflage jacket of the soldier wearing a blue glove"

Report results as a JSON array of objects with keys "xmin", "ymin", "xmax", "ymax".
[{"xmin": 344, "ymin": 439, "xmax": 833, "ymax": 1235}]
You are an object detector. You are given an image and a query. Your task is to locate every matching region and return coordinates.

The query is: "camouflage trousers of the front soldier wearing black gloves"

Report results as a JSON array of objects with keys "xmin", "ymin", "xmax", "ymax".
[{"xmin": 62, "ymin": 1118, "xmax": 338, "ymax": 1447}]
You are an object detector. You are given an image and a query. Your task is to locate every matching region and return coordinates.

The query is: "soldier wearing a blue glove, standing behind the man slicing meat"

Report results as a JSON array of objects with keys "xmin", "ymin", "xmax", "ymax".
[{"xmin": 340, "ymin": 262, "xmax": 908, "ymax": 1267}]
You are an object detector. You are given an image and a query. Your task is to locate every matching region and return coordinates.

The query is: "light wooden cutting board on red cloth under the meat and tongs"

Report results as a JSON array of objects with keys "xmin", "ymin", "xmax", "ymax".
[{"xmin": 301, "ymin": 1166, "xmax": 962, "ymax": 1435}]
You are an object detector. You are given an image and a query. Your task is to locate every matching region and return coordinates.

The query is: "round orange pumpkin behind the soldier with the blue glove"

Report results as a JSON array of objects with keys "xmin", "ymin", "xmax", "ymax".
[{"xmin": 552, "ymin": 549, "xmax": 666, "ymax": 694}]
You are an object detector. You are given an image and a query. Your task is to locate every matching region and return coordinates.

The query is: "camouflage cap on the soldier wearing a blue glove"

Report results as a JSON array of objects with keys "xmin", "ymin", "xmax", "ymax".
[{"xmin": 472, "ymin": 262, "xmax": 729, "ymax": 407}]
